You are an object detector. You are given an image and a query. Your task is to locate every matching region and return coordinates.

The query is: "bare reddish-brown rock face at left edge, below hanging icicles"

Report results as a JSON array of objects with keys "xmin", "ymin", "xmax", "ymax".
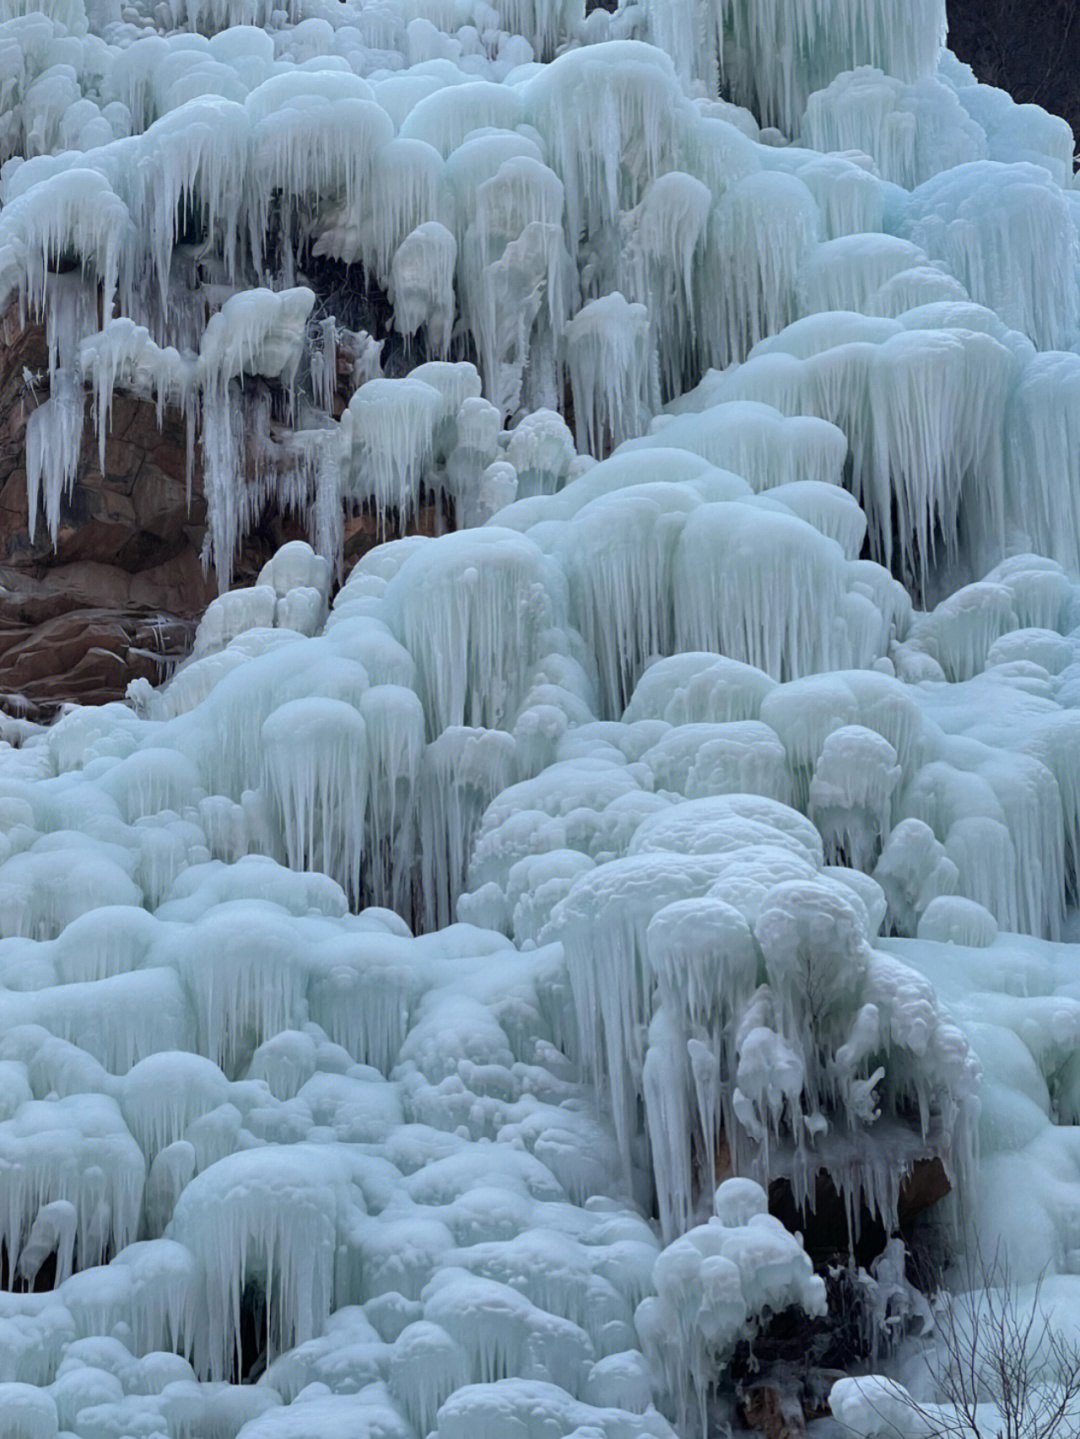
[{"xmin": 0, "ymin": 314, "xmax": 214, "ymax": 717}]
